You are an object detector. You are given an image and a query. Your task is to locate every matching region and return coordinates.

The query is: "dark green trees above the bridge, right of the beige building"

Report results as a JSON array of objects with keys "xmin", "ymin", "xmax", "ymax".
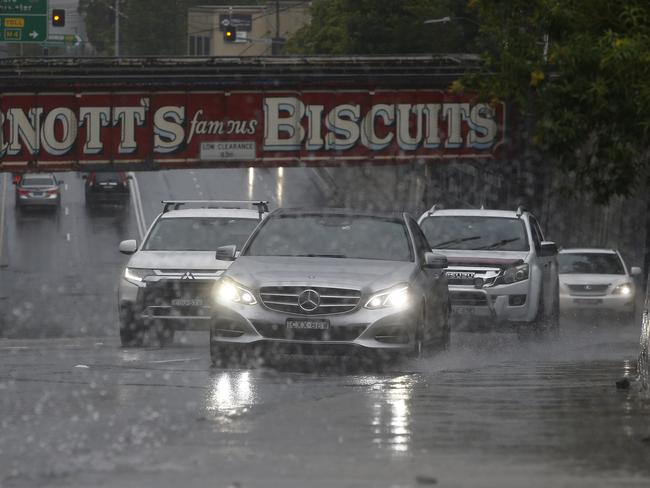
[{"xmin": 286, "ymin": 0, "xmax": 476, "ymax": 55}]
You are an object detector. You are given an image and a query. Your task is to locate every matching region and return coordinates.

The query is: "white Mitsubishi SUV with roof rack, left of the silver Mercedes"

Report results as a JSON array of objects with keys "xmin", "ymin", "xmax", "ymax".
[{"xmin": 118, "ymin": 200, "xmax": 268, "ymax": 346}]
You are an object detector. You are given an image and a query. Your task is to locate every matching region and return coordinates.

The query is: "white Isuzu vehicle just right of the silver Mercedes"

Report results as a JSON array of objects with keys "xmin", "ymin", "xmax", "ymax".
[{"xmin": 418, "ymin": 206, "xmax": 560, "ymax": 335}]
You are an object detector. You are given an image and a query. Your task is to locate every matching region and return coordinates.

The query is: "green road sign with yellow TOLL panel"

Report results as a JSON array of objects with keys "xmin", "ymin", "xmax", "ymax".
[{"xmin": 0, "ymin": 0, "xmax": 49, "ymax": 43}]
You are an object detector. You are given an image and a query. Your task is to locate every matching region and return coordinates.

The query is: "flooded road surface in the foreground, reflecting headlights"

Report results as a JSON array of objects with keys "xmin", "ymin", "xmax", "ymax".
[{"xmin": 0, "ymin": 324, "xmax": 650, "ymax": 488}]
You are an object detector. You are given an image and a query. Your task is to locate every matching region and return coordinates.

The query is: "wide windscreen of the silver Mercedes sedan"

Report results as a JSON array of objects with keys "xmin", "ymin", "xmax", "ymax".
[{"xmin": 245, "ymin": 214, "xmax": 413, "ymax": 261}]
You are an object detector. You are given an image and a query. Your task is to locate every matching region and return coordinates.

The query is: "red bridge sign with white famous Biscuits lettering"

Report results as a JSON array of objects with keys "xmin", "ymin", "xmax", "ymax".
[{"xmin": 0, "ymin": 90, "xmax": 505, "ymax": 172}]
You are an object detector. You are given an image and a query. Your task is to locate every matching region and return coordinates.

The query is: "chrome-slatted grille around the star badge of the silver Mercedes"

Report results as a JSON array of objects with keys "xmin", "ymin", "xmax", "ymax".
[{"xmin": 260, "ymin": 286, "xmax": 361, "ymax": 315}]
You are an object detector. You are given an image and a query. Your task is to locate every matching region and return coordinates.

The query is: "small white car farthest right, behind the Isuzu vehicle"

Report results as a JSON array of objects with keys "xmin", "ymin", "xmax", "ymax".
[{"xmin": 558, "ymin": 248, "xmax": 641, "ymax": 319}]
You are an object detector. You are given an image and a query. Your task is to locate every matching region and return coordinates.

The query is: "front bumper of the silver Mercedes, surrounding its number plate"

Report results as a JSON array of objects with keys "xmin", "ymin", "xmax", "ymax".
[{"xmin": 212, "ymin": 303, "xmax": 416, "ymax": 352}]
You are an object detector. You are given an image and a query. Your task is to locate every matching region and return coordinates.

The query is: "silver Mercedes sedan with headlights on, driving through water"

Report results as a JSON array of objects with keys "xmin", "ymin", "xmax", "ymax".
[{"xmin": 210, "ymin": 209, "xmax": 450, "ymax": 366}]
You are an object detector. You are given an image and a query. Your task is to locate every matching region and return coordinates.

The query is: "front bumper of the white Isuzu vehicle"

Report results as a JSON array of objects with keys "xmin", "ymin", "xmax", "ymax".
[{"xmin": 449, "ymin": 280, "xmax": 537, "ymax": 322}]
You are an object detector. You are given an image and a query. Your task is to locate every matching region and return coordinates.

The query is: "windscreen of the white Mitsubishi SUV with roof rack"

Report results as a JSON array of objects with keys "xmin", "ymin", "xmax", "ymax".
[{"xmin": 143, "ymin": 217, "xmax": 258, "ymax": 251}]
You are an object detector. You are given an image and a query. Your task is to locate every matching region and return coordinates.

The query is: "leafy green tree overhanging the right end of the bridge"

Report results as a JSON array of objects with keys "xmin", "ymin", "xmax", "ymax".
[{"xmin": 464, "ymin": 0, "xmax": 650, "ymax": 203}]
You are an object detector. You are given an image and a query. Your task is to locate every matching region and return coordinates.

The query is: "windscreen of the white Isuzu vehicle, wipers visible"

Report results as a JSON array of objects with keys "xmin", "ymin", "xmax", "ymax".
[{"xmin": 420, "ymin": 215, "xmax": 530, "ymax": 251}]
